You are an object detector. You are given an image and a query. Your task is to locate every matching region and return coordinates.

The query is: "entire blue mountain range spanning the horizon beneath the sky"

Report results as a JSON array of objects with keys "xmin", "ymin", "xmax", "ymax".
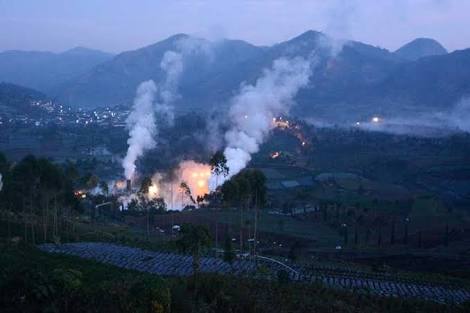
[{"xmin": 0, "ymin": 31, "xmax": 470, "ymax": 123}]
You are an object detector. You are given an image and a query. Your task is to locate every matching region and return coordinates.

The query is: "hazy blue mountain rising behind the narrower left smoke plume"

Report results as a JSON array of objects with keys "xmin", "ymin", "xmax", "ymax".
[{"xmin": 57, "ymin": 34, "xmax": 265, "ymax": 107}]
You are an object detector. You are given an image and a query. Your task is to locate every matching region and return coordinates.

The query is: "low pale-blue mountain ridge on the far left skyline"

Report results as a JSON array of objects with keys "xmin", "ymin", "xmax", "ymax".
[{"xmin": 0, "ymin": 47, "xmax": 112, "ymax": 93}]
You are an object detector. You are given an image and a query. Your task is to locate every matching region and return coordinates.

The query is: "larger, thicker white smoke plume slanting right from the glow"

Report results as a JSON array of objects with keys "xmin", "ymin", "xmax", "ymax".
[{"xmin": 211, "ymin": 57, "xmax": 311, "ymax": 187}]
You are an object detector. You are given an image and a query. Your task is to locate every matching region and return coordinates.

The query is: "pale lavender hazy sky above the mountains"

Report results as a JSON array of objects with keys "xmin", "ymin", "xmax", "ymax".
[{"xmin": 0, "ymin": 0, "xmax": 470, "ymax": 52}]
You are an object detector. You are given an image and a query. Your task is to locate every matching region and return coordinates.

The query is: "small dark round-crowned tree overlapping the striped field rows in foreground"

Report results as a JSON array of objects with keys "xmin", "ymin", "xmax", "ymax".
[{"xmin": 177, "ymin": 224, "xmax": 212, "ymax": 276}]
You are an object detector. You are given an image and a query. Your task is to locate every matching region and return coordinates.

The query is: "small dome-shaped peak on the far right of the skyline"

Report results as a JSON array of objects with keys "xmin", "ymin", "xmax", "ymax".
[{"xmin": 395, "ymin": 38, "xmax": 448, "ymax": 61}]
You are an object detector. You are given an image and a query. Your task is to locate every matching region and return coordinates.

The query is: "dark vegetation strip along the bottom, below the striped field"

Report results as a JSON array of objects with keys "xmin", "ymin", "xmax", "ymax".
[{"xmin": 0, "ymin": 242, "xmax": 470, "ymax": 313}]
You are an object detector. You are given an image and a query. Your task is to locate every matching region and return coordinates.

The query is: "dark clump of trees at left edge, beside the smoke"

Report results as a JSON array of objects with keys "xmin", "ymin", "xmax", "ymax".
[{"xmin": 0, "ymin": 153, "xmax": 79, "ymax": 243}]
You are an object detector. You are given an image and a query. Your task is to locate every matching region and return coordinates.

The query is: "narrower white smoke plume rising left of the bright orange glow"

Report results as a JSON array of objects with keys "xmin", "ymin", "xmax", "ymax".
[{"xmin": 122, "ymin": 80, "xmax": 157, "ymax": 179}]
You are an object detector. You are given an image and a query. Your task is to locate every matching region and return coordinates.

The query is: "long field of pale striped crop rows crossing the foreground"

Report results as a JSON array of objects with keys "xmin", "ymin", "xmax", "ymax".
[{"xmin": 39, "ymin": 242, "xmax": 470, "ymax": 303}]
